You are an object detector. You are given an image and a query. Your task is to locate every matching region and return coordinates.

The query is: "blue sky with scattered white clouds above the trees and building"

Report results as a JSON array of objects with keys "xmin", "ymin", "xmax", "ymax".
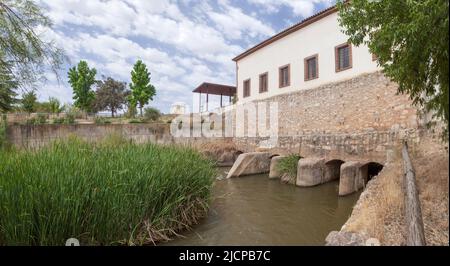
[{"xmin": 37, "ymin": 0, "xmax": 335, "ymax": 113}]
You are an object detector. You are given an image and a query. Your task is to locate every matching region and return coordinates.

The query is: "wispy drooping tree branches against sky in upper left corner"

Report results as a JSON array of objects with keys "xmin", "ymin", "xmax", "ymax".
[{"xmin": 0, "ymin": 0, "xmax": 65, "ymax": 89}]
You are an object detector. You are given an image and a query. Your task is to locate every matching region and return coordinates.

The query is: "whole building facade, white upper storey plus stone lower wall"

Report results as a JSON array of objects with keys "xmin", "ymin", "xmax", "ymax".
[{"xmin": 229, "ymin": 7, "xmax": 421, "ymax": 159}]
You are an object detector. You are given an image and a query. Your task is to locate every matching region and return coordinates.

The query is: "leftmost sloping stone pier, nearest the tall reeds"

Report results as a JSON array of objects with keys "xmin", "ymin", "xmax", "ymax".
[{"xmin": 227, "ymin": 152, "xmax": 270, "ymax": 178}]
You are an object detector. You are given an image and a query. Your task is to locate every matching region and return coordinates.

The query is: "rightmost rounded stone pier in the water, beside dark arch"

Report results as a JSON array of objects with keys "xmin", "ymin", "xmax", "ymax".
[{"xmin": 339, "ymin": 162, "xmax": 367, "ymax": 196}]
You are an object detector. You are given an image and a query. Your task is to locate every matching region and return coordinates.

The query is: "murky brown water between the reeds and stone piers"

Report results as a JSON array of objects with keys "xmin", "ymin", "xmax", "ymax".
[{"xmin": 166, "ymin": 169, "xmax": 359, "ymax": 245}]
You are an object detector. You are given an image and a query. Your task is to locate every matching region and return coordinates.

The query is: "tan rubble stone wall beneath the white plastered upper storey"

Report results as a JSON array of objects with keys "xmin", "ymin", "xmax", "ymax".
[{"xmin": 234, "ymin": 72, "xmax": 425, "ymax": 162}]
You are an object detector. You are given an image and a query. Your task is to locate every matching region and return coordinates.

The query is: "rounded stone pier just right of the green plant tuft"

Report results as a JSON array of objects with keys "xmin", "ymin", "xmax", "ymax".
[{"xmin": 296, "ymin": 158, "xmax": 325, "ymax": 187}]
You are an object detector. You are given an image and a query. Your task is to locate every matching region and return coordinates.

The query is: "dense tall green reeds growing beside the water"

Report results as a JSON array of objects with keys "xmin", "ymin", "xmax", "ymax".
[{"xmin": 0, "ymin": 139, "xmax": 215, "ymax": 245}]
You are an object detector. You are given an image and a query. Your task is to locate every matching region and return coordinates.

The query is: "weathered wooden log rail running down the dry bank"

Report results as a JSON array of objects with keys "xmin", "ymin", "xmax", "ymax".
[{"xmin": 402, "ymin": 141, "xmax": 426, "ymax": 246}]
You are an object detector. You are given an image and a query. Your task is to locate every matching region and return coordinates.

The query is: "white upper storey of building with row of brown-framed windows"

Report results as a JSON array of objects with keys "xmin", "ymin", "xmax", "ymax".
[{"xmin": 233, "ymin": 7, "xmax": 380, "ymax": 103}]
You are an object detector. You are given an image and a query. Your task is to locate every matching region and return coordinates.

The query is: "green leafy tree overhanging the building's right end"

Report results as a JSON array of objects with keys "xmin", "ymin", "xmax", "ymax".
[{"xmin": 337, "ymin": 0, "xmax": 449, "ymax": 136}]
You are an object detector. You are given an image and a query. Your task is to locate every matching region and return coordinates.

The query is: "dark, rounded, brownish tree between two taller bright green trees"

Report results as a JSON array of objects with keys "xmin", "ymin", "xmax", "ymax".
[{"xmin": 94, "ymin": 77, "xmax": 130, "ymax": 117}]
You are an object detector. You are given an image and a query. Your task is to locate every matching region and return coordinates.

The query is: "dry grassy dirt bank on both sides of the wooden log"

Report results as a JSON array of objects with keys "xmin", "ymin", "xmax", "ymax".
[{"xmin": 342, "ymin": 135, "xmax": 449, "ymax": 245}]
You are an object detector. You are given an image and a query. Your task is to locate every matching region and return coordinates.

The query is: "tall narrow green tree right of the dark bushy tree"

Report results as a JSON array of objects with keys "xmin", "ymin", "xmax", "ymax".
[{"xmin": 128, "ymin": 60, "xmax": 156, "ymax": 116}]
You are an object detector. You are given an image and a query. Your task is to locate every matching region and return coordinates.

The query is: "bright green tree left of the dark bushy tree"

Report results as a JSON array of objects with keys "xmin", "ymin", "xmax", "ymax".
[{"xmin": 68, "ymin": 61, "xmax": 97, "ymax": 112}]
